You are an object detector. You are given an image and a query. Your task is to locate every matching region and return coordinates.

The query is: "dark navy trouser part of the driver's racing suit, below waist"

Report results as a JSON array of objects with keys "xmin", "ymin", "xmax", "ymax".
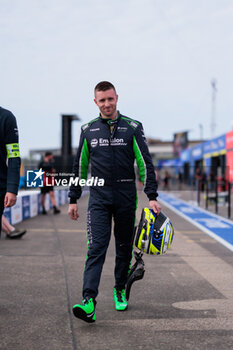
[{"xmin": 83, "ymin": 183, "xmax": 137, "ymax": 298}]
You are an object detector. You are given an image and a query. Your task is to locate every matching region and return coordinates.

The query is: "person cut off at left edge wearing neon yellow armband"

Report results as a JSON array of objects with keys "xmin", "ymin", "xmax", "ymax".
[{"xmin": 0, "ymin": 107, "xmax": 20, "ymax": 238}]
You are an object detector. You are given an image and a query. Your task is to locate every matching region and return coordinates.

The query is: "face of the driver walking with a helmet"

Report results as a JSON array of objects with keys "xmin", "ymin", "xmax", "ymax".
[{"xmin": 94, "ymin": 89, "xmax": 118, "ymax": 119}]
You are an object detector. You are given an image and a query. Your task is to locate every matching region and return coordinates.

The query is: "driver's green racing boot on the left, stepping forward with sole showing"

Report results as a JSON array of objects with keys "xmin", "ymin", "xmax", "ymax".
[{"xmin": 73, "ymin": 297, "xmax": 96, "ymax": 323}]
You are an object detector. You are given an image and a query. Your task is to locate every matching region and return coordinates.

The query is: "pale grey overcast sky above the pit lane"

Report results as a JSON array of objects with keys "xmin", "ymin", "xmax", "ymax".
[{"xmin": 0, "ymin": 0, "xmax": 233, "ymax": 156}]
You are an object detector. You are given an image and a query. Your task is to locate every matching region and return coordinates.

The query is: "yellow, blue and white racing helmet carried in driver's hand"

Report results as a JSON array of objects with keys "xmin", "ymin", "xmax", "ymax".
[{"xmin": 135, "ymin": 208, "xmax": 174, "ymax": 255}]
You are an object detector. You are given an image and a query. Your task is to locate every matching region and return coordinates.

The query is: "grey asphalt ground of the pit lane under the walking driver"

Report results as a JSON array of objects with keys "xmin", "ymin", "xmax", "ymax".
[{"xmin": 0, "ymin": 193, "xmax": 233, "ymax": 350}]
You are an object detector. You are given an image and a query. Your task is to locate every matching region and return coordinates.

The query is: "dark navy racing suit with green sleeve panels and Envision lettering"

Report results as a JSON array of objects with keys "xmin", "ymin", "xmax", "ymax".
[{"xmin": 69, "ymin": 113, "xmax": 157, "ymax": 298}]
